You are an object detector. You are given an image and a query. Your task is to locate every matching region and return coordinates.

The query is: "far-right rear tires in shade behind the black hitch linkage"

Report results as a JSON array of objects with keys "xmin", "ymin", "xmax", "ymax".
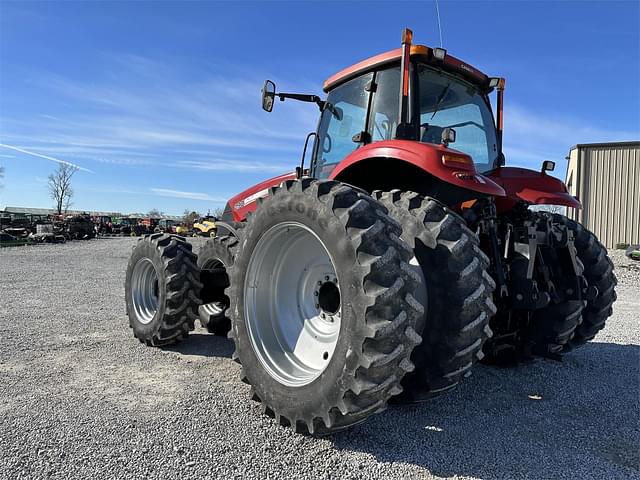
[{"xmin": 485, "ymin": 212, "xmax": 617, "ymax": 365}]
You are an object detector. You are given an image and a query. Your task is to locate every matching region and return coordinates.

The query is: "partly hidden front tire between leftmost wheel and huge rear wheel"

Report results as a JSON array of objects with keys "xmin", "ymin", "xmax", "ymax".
[{"xmin": 198, "ymin": 236, "xmax": 238, "ymax": 335}]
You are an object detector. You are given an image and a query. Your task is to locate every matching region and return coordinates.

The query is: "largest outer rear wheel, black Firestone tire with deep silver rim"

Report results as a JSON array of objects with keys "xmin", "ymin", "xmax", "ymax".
[{"xmin": 229, "ymin": 178, "xmax": 424, "ymax": 434}]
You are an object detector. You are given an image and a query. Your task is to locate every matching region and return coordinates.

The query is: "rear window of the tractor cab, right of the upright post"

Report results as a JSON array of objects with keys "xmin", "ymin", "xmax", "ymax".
[{"xmin": 418, "ymin": 65, "xmax": 498, "ymax": 172}]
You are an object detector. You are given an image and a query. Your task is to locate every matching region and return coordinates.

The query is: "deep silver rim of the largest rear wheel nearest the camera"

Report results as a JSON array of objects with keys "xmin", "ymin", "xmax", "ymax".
[{"xmin": 244, "ymin": 222, "xmax": 341, "ymax": 387}]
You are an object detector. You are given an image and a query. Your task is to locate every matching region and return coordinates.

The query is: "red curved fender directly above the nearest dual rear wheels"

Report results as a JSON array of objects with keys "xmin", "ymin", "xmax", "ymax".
[{"xmin": 329, "ymin": 140, "xmax": 505, "ymax": 197}]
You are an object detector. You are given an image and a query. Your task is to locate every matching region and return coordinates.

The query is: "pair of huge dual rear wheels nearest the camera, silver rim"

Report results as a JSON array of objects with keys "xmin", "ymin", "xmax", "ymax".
[{"xmin": 230, "ymin": 179, "xmax": 495, "ymax": 433}]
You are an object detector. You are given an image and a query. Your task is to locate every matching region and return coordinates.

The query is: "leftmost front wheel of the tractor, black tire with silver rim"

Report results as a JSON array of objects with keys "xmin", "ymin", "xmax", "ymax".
[{"xmin": 125, "ymin": 233, "xmax": 202, "ymax": 347}]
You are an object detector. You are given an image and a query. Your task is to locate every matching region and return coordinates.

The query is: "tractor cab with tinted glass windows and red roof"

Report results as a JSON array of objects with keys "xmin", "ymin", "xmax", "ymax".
[{"xmin": 311, "ymin": 46, "xmax": 500, "ymax": 178}]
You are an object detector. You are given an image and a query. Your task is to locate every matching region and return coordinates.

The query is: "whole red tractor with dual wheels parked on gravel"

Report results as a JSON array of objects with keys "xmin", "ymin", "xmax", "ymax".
[{"xmin": 126, "ymin": 30, "xmax": 616, "ymax": 433}]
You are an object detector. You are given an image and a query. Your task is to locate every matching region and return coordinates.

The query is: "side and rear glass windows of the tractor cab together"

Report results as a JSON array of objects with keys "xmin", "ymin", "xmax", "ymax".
[{"xmin": 312, "ymin": 64, "xmax": 498, "ymax": 178}]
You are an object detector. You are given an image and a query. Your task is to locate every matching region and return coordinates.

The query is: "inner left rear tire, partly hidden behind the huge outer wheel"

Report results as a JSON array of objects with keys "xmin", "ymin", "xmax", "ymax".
[{"xmin": 373, "ymin": 190, "xmax": 496, "ymax": 402}]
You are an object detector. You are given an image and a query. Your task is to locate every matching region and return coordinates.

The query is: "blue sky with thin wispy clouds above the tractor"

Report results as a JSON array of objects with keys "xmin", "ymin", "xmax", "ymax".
[{"xmin": 0, "ymin": 0, "xmax": 640, "ymax": 214}]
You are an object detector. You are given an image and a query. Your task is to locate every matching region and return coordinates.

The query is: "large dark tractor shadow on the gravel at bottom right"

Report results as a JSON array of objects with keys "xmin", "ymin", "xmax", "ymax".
[{"xmin": 333, "ymin": 343, "xmax": 640, "ymax": 479}]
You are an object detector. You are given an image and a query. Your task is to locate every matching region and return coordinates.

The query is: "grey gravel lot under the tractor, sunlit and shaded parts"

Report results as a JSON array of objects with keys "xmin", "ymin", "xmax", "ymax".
[{"xmin": 0, "ymin": 238, "xmax": 640, "ymax": 479}]
